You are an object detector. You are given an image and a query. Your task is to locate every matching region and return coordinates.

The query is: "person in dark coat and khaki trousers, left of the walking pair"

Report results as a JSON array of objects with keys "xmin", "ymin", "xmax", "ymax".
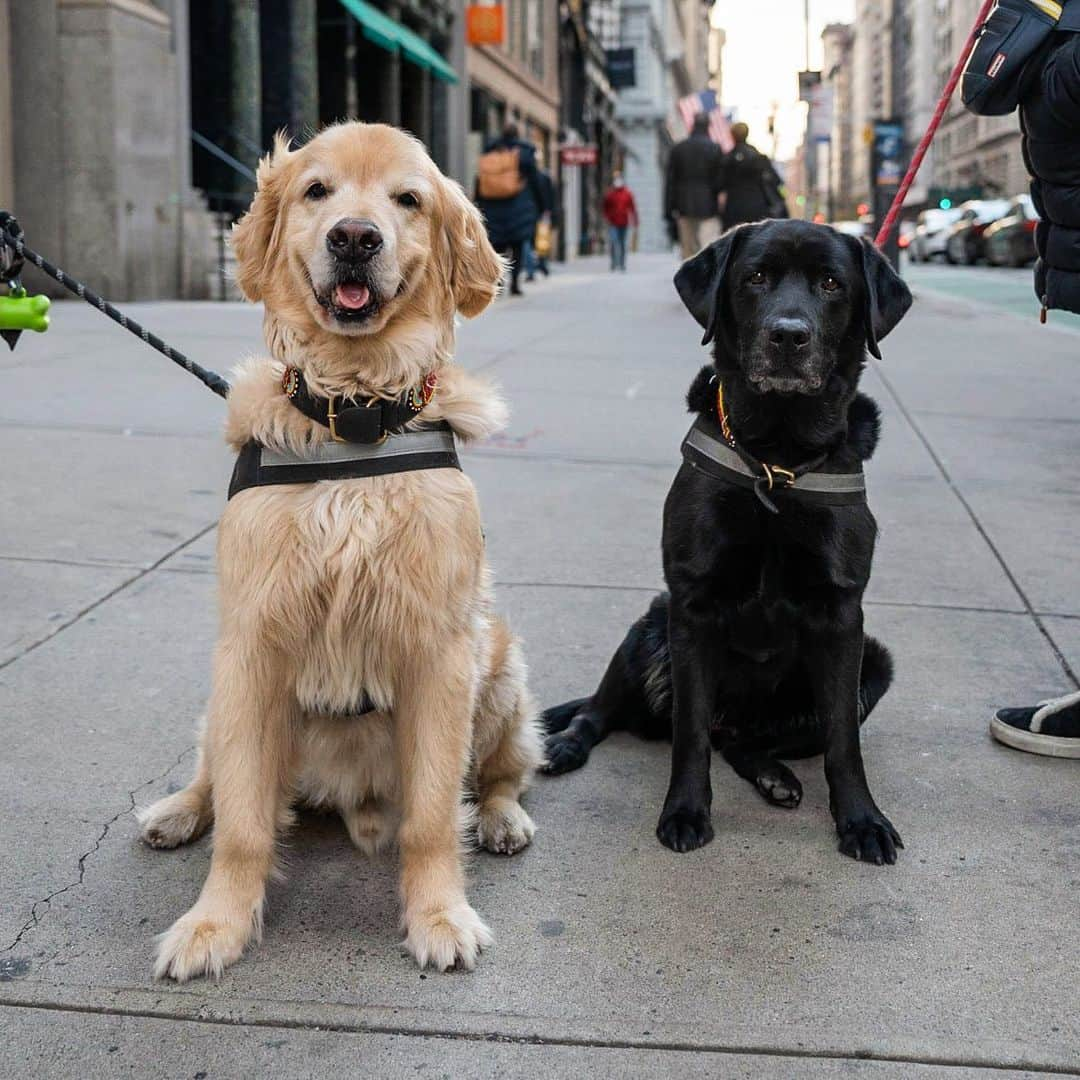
[{"xmin": 664, "ymin": 112, "xmax": 724, "ymax": 259}]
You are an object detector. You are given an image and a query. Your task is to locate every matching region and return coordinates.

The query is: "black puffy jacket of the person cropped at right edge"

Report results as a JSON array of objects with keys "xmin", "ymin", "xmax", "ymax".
[{"xmin": 1021, "ymin": 24, "xmax": 1080, "ymax": 312}]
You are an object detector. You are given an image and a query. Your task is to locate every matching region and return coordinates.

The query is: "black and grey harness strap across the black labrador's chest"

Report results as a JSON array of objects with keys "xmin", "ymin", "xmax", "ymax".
[{"xmin": 683, "ymin": 416, "xmax": 866, "ymax": 514}]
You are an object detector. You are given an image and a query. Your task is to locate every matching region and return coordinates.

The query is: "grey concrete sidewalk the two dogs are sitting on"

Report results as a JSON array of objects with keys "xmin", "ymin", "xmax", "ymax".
[{"xmin": 0, "ymin": 257, "xmax": 1080, "ymax": 1080}]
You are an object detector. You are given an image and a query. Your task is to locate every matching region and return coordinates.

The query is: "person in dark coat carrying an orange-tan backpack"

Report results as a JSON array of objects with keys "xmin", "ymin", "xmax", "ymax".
[{"xmin": 476, "ymin": 123, "xmax": 544, "ymax": 296}]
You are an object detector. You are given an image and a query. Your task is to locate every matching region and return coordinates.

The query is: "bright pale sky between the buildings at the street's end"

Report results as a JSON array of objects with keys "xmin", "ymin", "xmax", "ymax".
[{"xmin": 712, "ymin": 0, "xmax": 855, "ymax": 161}]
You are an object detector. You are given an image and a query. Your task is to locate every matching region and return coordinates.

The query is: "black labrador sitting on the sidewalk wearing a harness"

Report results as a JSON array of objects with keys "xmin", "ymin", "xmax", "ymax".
[{"xmin": 544, "ymin": 221, "xmax": 912, "ymax": 864}]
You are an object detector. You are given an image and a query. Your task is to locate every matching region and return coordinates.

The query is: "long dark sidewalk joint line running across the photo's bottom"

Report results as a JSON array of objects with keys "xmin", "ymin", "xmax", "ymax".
[{"xmin": 0, "ymin": 998, "xmax": 1080, "ymax": 1077}]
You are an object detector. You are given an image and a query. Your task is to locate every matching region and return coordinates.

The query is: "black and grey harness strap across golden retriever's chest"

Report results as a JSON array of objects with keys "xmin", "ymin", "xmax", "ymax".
[{"xmin": 229, "ymin": 420, "xmax": 461, "ymax": 499}]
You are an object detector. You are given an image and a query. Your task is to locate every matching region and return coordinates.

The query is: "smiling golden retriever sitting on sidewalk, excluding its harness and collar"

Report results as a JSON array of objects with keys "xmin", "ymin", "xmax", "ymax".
[{"xmin": 140, "ymin": 123, "xmax": 541, "ymax": 981}]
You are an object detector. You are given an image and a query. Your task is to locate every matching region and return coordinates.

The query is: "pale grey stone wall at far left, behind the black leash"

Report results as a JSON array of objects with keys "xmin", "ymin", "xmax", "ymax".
[{"xmin": 0, "ymin": 0, "xmax": 212, "ymax": 299}]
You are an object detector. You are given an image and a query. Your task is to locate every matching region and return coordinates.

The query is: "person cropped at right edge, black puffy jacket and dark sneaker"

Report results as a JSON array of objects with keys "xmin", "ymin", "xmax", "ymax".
[{"xmin": 990, "ymin": 12, "xmax": 1080, "ymax": 758}]
